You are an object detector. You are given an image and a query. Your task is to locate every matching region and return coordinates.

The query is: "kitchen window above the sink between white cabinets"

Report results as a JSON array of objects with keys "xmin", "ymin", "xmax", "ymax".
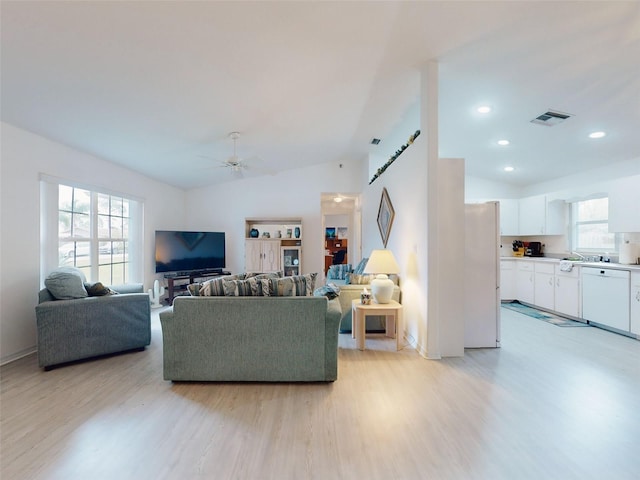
[{"xmin": 571, "ymin": 197, "xmax": 619, "ymax": 253}]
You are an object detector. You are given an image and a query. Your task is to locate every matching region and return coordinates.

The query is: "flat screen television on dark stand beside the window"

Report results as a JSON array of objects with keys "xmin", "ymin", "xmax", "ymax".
[{"xmin": 156, "ymin": 230, "xmax": 226, "ymax": 273}]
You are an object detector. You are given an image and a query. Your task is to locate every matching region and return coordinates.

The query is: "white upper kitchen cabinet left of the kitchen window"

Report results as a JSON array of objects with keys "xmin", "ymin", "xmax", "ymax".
[{"xmin": 518, "ymin": 195, "xmax": 566, "ymax": 235}]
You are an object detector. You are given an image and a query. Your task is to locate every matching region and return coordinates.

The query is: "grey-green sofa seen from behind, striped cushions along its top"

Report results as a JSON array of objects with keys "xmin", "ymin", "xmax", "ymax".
[{"xmin": 160, "ymin": 296, "xmax": 341, "ymax": 382}]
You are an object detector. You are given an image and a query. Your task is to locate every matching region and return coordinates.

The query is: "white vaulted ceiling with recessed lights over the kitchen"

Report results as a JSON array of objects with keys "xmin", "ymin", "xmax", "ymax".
[{"xmin": 0, "ymin": 0, "xmax": 640, "ymax": 188}]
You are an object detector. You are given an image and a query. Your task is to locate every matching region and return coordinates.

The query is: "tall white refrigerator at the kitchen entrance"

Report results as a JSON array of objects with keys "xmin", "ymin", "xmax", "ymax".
[{"xmin": 463, "ymin": 202, "xmax": 500, "ymax": 348}]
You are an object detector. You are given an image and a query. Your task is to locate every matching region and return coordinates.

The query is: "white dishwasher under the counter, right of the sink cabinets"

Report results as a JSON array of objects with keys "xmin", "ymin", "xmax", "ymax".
[{"xmin": 582, "ymin": 267, "xmax": 631, "ymax": 332}]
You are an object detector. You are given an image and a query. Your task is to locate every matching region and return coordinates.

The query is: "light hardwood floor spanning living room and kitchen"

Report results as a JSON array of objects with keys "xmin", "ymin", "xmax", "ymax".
[{"xmin": 0, "ymin": 309, "xmax": 640, "ymax": 480}]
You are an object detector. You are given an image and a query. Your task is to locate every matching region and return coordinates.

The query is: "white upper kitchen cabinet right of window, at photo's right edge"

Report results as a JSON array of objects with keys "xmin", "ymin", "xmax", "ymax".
[{"xmin": 609, "ymin": 175, "xmax": 640, "ymax": 233}]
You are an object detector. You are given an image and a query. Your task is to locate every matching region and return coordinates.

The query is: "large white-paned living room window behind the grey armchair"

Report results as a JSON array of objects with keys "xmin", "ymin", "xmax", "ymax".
[{"xmin": 41, "ymin": 178, "xmax": 142, "ymax": 285}]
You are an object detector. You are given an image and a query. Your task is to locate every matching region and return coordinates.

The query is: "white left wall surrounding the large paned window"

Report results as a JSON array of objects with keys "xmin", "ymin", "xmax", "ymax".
[{"xmin": 0, "ymin": 123, "xmax": 184, "ymax": 363}]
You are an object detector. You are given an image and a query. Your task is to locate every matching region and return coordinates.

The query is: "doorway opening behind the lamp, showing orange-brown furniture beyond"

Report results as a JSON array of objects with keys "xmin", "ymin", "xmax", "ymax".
[{"xmin": 321, "ymin": 193, "xmax": 362, "ymax": 279}]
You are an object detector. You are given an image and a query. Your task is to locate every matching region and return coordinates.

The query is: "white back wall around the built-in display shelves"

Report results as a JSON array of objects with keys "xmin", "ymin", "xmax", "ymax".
[{"xmin": 186, "ymin": 159, "xmax": 367, "ymax": 273}]
